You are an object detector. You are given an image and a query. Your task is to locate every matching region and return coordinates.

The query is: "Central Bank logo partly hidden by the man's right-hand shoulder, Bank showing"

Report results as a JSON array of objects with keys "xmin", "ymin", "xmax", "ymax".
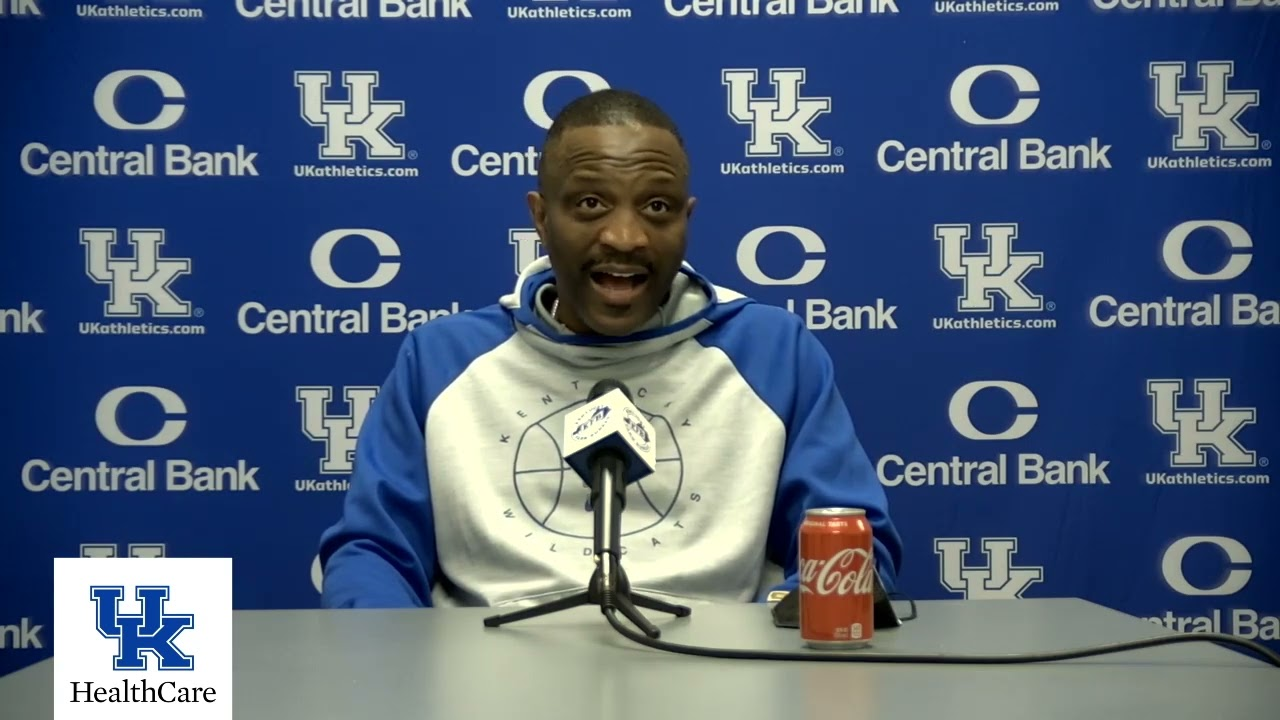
[{"xmin": 736, "ymin": 225, "xmax": 897, "ymax": 331}]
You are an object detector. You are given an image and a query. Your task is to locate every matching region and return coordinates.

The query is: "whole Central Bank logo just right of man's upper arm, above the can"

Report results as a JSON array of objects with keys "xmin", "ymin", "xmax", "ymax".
[{"xmin": 876, "ymin": 379, "xmax": 1111, "ymax": 488}]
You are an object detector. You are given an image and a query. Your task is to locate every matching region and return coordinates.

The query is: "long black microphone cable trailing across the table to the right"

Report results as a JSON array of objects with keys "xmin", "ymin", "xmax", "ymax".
[{"xmin": 600, "ymin": 598, "xmax": 1280, "ymax": 667}]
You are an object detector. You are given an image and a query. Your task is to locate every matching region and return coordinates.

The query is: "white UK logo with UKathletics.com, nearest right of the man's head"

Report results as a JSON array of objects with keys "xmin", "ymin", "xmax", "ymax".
[{"xmin": 721, "ymin": 68, "xmax": 845, "ymax": 176}]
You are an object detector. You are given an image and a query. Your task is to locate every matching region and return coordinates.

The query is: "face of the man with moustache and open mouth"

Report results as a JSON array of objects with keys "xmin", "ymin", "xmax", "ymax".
[{"xmin": 529, "ymin": 126, "xmax": 694, "ymax": 336}]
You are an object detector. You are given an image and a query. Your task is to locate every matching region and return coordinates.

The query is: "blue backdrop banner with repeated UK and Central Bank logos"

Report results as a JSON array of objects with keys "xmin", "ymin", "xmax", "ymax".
[{"xmin": 0, "ymin": 0, "xmax": 1280, "ymax": 673}]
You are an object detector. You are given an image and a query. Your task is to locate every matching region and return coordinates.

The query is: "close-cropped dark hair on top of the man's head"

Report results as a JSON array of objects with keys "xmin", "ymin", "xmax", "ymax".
[{"xmin": 538, "ymin": 88, "xmax": 687, "ymax": 191}]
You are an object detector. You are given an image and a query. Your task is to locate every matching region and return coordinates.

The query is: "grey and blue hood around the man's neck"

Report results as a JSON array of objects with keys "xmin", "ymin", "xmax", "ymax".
[{"xmin": 498, "ymin": 255, "xmax": 753, "ymax": 368}]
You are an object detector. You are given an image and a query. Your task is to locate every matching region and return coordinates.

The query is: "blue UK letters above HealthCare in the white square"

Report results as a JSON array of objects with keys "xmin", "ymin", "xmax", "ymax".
[{"xmin": 90, "ymin": 585, "xmax": 196, "ymax": 670}]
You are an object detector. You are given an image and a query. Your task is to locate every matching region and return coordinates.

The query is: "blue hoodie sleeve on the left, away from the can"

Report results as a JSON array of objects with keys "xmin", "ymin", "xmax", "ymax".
[{"xmin": 320, "ymin": 333, "xmax": 435, "ymax": 609}]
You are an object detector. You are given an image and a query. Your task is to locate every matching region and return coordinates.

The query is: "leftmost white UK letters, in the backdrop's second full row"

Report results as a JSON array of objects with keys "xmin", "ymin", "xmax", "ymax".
[{"xmin": 79, "ymin": 228, "xmax": 192, "ymax": 318}]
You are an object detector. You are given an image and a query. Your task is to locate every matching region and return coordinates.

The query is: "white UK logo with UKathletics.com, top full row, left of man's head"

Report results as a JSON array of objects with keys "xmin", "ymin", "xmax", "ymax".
[{"xmin": 293, "ymin": 70, "xmax": 420, "ymax": 178}]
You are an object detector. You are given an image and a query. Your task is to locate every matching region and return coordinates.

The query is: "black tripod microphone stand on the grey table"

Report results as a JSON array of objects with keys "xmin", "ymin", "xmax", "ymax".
[{"xmin": 484, "ymin": 450, "xmax": 692, "ymax": 639}]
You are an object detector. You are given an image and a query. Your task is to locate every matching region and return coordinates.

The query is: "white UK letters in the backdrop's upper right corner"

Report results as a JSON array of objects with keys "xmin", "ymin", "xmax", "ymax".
[{"xmin": 1149, "ymin": 60, "xmax": 1262, "ymax": 152}]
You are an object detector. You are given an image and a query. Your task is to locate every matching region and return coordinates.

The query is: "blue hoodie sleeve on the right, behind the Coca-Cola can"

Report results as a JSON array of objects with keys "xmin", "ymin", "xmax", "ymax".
[{"xmin": 767, "ymin": 320, "xmax": 902, "ymax": 592}]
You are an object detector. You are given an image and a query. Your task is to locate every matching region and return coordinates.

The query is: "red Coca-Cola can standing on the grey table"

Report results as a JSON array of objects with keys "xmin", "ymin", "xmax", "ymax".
[{"xmin": 800, "ymin": 507, "xmax": 876, "ymax": 650}]
